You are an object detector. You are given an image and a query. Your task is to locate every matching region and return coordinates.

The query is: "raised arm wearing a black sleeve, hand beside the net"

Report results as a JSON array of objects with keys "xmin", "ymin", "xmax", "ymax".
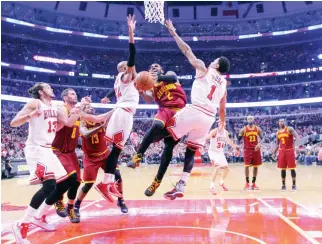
[{"xmin": 121, "ymin": 15, "xmax": 136, "ymax": 83}]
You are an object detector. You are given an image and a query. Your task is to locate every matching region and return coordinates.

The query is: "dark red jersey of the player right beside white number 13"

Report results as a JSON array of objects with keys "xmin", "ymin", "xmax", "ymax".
[{"xmin": 52, "ymin": 108, "xmax": 80, "ymax": 153}]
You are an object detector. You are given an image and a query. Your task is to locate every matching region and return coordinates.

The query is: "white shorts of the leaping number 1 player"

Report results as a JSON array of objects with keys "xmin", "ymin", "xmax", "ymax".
[{"xmin": 167, "ymin": 105, "xmax": 216, "ymax": 148}]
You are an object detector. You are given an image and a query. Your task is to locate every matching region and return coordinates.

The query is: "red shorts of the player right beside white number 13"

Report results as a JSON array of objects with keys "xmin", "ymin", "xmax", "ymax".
[{"xmin": 53, "ymin": 150, "xmax": 81, "ymax": 182}]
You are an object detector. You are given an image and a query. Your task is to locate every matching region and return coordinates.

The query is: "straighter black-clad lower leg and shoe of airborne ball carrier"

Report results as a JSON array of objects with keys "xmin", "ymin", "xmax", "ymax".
[{"xmin": 144, "ymin": 136, "xmax": 179, "ymax": 197}]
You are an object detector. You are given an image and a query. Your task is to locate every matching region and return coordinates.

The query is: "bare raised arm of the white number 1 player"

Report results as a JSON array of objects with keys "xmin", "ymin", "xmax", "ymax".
[{"xmin": 165, "ymin": 20, "xmax": 207, "ymax": 76}]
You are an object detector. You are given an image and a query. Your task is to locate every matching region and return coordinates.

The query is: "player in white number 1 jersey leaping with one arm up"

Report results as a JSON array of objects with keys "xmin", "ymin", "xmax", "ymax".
[{"xmin": 164, "ymin": 20, "xmax": 230, "ymax": 200}]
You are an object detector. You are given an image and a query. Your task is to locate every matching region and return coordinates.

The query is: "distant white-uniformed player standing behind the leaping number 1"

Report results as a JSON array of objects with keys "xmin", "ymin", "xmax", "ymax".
[{"xmin": 206, "ymin": 128, "xmax": 236, "ymax": 195}]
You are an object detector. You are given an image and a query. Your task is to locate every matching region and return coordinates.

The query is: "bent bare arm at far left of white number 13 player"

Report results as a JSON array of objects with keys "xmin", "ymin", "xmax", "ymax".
[{"xmin": 10, "ymin": 99, "xmax": 41, "ymax": 127}]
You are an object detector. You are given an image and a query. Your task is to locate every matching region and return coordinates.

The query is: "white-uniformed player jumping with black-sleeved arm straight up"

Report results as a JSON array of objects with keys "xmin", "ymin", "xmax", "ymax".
[{"xmin": 95, "ymin": 15, "xmax": 140, "ymax": 202}]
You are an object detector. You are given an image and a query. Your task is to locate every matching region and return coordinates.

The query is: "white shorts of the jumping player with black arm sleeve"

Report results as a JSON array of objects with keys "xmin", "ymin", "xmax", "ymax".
[{"xmin": 105, "ymin": 108, "xmax": 133, "ymax": 149}]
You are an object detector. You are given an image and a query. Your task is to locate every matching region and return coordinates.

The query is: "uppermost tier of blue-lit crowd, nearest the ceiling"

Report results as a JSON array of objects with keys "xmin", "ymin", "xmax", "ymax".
[{"xmin": 1, "ymin": 2, "xmax": 322, "ymax": 37}]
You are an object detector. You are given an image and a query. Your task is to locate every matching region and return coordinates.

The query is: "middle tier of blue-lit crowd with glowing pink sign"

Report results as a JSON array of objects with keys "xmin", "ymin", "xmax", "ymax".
[{"xmin": 1, "ymin": 35, "xmax": 322, "ymax": 75}]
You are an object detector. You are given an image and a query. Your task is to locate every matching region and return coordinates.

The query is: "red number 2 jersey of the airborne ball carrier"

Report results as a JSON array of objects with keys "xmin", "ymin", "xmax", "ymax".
[{"xmin": 153, "ymin": 82, "xmax": 187, "ymax": 109}]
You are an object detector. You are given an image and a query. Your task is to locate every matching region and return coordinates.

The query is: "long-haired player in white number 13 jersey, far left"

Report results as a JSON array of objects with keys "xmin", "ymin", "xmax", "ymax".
[{"xmin": 10, "ymin": 82, "xmax": 88, "ymax": 243}]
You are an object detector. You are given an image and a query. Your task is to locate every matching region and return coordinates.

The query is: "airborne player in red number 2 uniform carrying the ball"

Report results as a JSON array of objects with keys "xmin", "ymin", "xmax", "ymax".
[{"xmin": 128, "ymin": 64, "xmax": 187, "ymax": 197}]
